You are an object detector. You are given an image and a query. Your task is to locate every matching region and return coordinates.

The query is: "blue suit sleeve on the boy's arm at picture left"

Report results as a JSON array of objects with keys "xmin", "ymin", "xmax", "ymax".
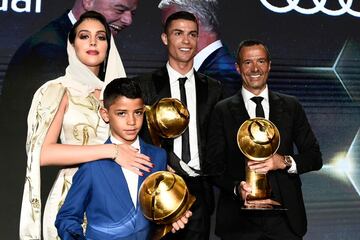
[{"xmin": 55, "ymin": 163, "xmax": 92, "ymax": 240}]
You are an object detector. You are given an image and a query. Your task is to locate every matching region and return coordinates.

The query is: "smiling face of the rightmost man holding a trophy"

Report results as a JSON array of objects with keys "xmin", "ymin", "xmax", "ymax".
[{"xmin": 236, "ymin": 45, "xmax": 271, "ymax": 95}]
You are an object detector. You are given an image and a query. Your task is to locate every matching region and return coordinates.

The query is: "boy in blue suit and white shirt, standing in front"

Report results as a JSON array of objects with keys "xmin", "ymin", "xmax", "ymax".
[{"xmin": 55, "ymin": 78, "xmax": 191, "ymax": 240}]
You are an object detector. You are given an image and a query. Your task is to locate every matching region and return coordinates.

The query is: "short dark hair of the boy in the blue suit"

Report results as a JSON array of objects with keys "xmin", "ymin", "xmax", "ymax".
[{"xmin": 104, "ymin": 78, "xmax": 143, "ymax": 109}]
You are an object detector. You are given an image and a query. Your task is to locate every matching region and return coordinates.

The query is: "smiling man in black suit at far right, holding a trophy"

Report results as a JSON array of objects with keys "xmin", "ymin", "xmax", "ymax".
[{"xmin": 204, "ymin": 40, "xmax": 322, "ymax": 240}]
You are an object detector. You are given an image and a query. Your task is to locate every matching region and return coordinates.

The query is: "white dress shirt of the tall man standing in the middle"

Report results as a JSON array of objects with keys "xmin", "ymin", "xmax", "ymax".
[{"xmin": 166, "ymin": 63, "xmax": 200, "ymax": 176}]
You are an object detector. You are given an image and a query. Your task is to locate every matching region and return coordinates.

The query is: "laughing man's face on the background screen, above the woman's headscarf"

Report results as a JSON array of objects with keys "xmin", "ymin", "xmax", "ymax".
[{"xmin": 87, "ymin": 0, "xmax": 138, "ymax": 35}]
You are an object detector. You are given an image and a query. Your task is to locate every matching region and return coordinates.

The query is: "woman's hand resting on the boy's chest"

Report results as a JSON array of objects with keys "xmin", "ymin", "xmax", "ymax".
[{"xmin": 115, "ymin": 144, "xmax": 154, "ymax": 176}]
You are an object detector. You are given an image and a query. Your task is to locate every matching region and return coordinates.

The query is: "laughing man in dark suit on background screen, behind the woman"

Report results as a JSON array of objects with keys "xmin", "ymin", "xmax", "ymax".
[{"xmin": 0, "ymin": 0, "xmax": 138, "ymax": 239}]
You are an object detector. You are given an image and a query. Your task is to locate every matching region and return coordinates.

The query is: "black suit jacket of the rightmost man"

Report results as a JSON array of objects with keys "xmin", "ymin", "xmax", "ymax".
[{"xmin": 204, "ymin": 91, "xmax": 322, "ymax": 236}]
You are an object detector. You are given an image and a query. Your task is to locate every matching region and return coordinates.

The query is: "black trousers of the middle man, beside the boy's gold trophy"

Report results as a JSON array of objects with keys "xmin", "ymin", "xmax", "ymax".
[{"xmin": 162, "ymin": 177, "xmax": 214, "ymax": 240}]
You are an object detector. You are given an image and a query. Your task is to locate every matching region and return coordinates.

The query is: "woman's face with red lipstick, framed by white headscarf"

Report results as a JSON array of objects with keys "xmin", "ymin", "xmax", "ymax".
[{"xmin": 73, "ymin": 19, "xmax": 108, "ymax": 75}]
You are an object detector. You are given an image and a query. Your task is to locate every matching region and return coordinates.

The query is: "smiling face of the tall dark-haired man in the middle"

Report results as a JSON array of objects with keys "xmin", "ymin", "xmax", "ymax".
[{"xmin": 161, "ymin": 19, "xmax": 198, "ymax": 65}]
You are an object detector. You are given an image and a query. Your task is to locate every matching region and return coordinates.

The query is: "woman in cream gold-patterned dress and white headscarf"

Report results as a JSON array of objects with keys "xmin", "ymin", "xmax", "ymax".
[{"xmin": 20, "ymin": 11, "xmax": 152, "ymax": 239}]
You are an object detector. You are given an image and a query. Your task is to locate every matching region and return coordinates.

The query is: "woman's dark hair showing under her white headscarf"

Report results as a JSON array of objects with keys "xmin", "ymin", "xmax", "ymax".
[{"xmin": 69, "ymin": 11, "xmax": 111, "ymax": 47}]
